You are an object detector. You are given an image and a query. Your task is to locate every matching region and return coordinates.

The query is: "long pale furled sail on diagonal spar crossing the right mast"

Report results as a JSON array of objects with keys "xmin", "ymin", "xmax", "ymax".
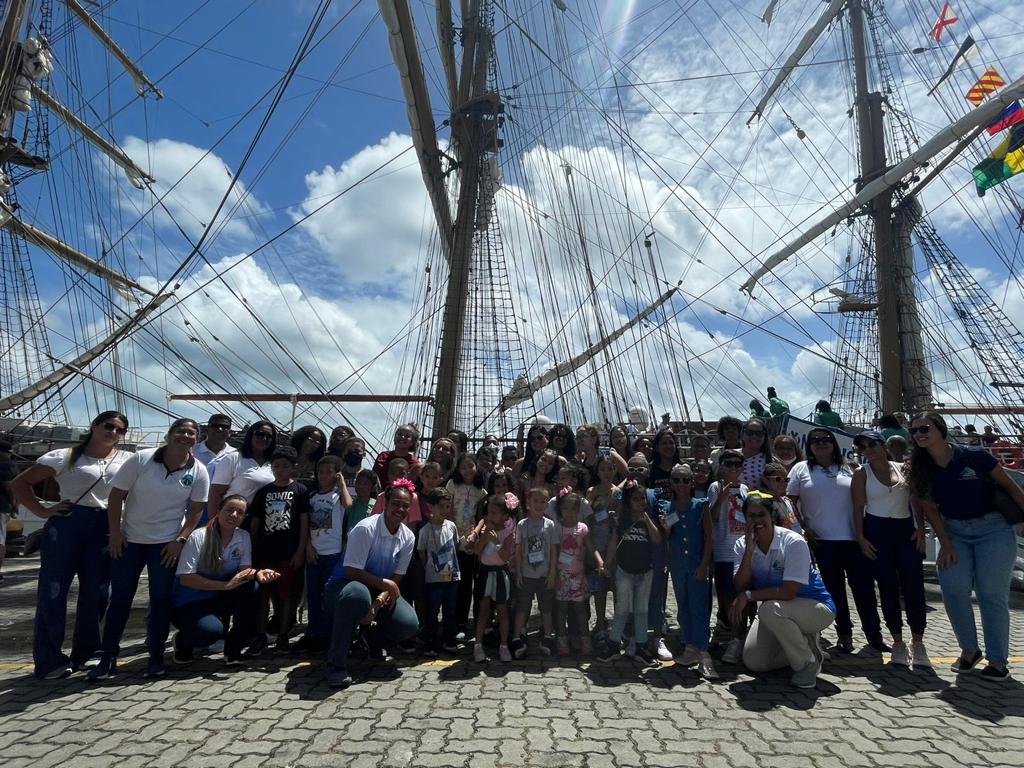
[{"xmin": 739, "ymin": 78, "xmax": 1024, "ymax": 293}]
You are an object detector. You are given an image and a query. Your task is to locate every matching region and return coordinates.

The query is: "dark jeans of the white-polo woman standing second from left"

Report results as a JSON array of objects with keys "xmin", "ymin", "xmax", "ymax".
[{"xmin": 103, "ymin": 542, "xmax": 174, "ymax": 658}]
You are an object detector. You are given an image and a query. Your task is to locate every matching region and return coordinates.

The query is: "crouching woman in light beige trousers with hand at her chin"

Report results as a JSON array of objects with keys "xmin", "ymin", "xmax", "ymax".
[{"xmin": 730, "ymin": 492, "xmax": 836, "ymax": 688}]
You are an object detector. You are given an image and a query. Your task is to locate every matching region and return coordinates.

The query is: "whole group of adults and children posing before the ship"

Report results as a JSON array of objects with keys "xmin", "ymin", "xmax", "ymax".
[{"xmin": 11, "ymin": 412, "xmax": 1024, "ymax": 687}]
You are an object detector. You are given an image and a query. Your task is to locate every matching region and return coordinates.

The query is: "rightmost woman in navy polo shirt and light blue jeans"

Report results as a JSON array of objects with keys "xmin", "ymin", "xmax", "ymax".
[{"xmin": 907, "ymin": 412, "xmax": 1024, "ymax": 680}]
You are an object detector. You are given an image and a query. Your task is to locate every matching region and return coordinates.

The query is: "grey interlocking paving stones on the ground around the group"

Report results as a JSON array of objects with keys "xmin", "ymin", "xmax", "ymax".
[{"xmin": 0, "ymin": 559, "xmax": 1024, "ymax": 768}]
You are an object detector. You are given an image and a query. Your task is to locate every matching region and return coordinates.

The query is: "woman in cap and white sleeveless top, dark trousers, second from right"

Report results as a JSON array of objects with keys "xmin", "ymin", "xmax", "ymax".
[{"xmin": 852, "ymin": 430, "xmax": 932, "ymax": 669}]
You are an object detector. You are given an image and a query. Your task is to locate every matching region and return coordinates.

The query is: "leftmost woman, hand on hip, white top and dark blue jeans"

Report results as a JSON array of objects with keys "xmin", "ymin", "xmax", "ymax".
[{"xmin": 11, "ymin": 411, "xmax": 131, "ymax": 680}]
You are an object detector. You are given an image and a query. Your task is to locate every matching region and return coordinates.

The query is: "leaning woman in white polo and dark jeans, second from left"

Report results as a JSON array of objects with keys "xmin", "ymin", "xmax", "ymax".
[{"xmin": 88, "ymin": 419, "xmax": 210, "ymax": 681}]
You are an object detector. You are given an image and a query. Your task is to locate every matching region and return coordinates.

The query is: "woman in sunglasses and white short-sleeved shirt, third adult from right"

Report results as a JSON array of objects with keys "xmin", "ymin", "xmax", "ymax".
[{"xmin": 786, "ymin": 427, "xmax": 889, "ymax": 653}]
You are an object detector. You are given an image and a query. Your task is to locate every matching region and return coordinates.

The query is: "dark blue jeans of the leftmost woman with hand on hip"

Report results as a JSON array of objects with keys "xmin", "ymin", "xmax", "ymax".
[{"xmin": 32, "ymin": 505, "xmax": 111, "ymax": 677}]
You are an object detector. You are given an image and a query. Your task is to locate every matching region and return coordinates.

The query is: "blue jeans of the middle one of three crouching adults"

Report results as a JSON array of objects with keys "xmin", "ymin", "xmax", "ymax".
[{"xmin": 324, "ymin": 582, "xmax": 420, "ymax": 670}]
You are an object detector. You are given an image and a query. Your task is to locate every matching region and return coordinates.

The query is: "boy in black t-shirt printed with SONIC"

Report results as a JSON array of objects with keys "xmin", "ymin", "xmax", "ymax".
[{"xmin": 248, "ymin": 445, "xmax": 309, "ymax": 653}]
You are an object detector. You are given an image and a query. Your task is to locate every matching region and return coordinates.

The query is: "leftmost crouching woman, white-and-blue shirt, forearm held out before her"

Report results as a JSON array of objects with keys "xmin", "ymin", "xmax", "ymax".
[{"xmin": 171, "ymin": 494, "xmax": 281, "ymax": 667}]
